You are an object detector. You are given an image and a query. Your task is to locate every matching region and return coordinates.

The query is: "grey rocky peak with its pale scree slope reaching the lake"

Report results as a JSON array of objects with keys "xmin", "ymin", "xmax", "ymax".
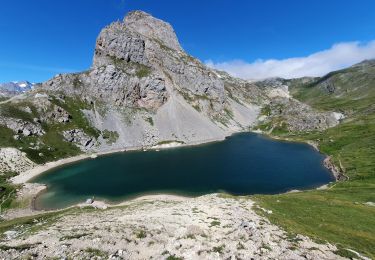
[{"xmin": 40, "ymin": 11, "xmax": 259, "ymax": 149}]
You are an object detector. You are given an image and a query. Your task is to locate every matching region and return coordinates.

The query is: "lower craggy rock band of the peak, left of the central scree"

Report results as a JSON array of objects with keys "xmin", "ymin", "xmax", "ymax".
[{"xmin": 45, "ymin": 64, "xmax": 168, "ymax": 110}]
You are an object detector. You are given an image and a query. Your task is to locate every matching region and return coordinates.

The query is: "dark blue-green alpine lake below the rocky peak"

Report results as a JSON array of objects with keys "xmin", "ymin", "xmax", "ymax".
[{"xmin": 31, "ymin": 133, "xmax": 334, "ymax": 209}]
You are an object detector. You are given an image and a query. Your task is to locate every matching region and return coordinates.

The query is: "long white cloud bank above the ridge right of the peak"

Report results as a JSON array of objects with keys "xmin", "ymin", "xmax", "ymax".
[{"xmin": 205, "ymin": 40, "xmax": 375, "ymax": 79}]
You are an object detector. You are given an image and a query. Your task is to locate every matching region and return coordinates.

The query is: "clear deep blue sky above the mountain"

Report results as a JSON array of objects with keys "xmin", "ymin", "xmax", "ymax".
[{"xmin": 0, "ymin": 0, "xmax": 375, "ymax": 82}]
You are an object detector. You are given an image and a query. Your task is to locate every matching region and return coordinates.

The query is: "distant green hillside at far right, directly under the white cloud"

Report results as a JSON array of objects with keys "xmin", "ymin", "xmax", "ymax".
[{"xmin": 287, "ymin": 60, "xmax": 375, "ymax": 116}]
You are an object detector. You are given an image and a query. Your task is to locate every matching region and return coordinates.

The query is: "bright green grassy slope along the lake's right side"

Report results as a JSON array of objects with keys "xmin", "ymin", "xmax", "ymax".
[{"xmin": 255, "ymin": 62, "xmax": 375, "ymax": 258}]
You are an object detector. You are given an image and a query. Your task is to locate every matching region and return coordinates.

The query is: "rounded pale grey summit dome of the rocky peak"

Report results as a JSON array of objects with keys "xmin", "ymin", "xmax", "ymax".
[{"xmin": 124, "ymin": 11, "xmax": 182, "ymax": 51}]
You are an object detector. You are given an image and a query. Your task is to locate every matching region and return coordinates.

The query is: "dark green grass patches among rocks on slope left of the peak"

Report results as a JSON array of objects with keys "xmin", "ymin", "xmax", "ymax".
[{"xmin": 0, "ymin": 96, "xmax": 100, "ymax": 163}]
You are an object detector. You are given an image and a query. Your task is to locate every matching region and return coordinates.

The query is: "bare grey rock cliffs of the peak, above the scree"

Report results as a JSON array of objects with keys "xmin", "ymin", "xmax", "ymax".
[{"xmin": 44, "ymin": 11, "xmax": 225, "ymax": 113}]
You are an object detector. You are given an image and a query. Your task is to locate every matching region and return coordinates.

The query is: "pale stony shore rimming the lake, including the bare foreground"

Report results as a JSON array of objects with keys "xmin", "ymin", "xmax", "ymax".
[{"xmin": 0, "ymin": 130, "xmax": 348, "ymax": 259}]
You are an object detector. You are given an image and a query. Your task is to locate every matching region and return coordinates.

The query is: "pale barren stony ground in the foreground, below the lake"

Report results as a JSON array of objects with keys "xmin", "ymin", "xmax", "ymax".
[{"xmin": 0, "ymin": 194, "xmax": 341, "ymax": 259}]
